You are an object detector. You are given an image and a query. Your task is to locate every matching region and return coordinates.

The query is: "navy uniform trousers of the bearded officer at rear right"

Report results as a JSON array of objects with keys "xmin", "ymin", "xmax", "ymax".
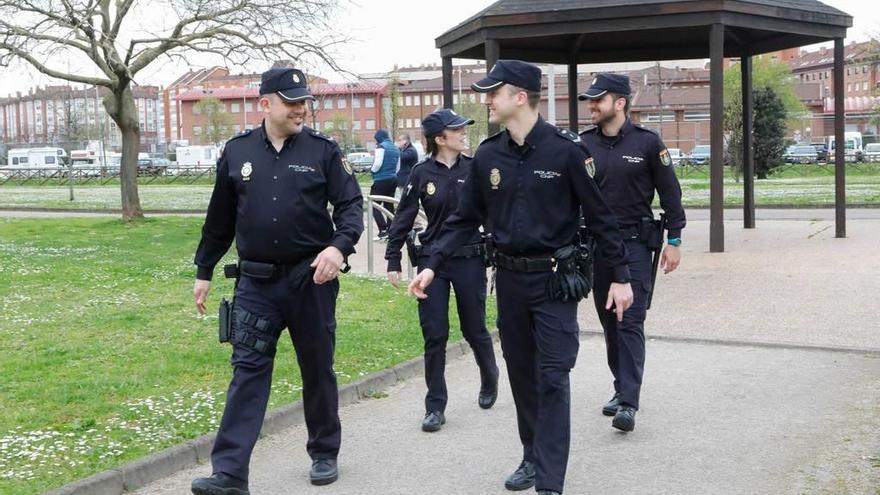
[{"xmin": 593, "ymin": 239, "xmax": 651, "ymax": 409}]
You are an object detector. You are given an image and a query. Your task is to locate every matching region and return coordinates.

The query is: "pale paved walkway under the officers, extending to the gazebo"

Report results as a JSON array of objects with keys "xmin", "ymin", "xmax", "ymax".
[{"xmin": 127, "ymin": 210, "xmax": 880, "ymax": 495}]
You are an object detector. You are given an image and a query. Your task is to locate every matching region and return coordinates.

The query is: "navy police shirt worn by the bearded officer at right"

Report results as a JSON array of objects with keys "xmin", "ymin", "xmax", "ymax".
[{"xmin": 581, "ymin": 119, "xmax": 685, "ymax": 238}]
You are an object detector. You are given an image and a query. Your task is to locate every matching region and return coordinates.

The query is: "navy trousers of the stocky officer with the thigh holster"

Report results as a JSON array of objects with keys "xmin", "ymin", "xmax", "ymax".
[{"xmin": 211, "ymin": 273, "xmax": 342, "ymax": 480}]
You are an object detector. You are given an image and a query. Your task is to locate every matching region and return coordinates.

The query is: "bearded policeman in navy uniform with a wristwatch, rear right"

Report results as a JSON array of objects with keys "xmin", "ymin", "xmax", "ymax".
[{"xmin": 578, "ymin": 73, "xmax": 685, "ymax": 431}]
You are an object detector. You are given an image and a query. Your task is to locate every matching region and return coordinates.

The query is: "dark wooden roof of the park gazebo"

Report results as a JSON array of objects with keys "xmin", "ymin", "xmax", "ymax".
[{"xmin": 436, "ymin": 0, "xmax": 852, "ymax": 64}]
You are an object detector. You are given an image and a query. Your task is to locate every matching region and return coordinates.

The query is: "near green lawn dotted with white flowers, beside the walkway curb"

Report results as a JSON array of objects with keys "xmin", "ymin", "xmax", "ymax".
[{"xmin": 0, "ymin": 217, "xmax": 494, "ymax": 495}]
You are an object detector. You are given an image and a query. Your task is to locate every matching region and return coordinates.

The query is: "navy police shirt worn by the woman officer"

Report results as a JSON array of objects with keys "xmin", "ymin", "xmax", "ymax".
[{"xmin": 385, "ymin": 154, "xmax": 480, "ymax": 271}]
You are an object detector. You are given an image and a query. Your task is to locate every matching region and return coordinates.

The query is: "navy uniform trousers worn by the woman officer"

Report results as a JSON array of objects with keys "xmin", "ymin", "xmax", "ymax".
[{"xmin": 419, "ymin": 256, "xmax": 498, "ymax": 412}]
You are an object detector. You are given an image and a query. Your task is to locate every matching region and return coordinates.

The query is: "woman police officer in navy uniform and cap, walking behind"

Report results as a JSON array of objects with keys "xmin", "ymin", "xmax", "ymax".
[{"xmin": 385, "ymin": 109, "xmax": 498, "ymax": 432}]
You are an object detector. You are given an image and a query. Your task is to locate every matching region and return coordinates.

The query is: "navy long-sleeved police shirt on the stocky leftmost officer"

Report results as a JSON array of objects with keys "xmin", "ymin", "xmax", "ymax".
[{"xmin": 195, "ymin": 126, "xmax": 364, "ymax": 280}]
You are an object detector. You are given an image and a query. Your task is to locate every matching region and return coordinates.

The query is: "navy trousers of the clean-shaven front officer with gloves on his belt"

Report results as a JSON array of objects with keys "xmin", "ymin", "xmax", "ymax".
[{"xmin": 497, "ymin": 268, "xmax": 580, "ymax": 492}]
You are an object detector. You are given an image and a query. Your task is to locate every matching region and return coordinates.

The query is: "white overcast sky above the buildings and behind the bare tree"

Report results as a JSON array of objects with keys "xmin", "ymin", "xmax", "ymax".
[{"xmin": 0, "ymin": 0, "xmax": 880, "ymax": 96}]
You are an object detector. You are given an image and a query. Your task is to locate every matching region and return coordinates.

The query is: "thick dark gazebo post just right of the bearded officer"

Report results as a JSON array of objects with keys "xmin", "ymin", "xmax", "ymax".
[{"xmin": 709, "ymin": 23, "xmax": 724, "ymax": 253}]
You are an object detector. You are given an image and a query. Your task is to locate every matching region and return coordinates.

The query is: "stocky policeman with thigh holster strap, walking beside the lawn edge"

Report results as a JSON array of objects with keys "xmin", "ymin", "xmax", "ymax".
[{"xmin": 192, "ymin": 69, "xmax": 364, "ymax": 495}]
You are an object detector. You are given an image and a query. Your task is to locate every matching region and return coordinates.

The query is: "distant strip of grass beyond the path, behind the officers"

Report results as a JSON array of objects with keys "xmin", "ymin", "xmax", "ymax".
[{"xmin": 0, "ymin": 163, "xmax": 880, "ymax": 211}]
